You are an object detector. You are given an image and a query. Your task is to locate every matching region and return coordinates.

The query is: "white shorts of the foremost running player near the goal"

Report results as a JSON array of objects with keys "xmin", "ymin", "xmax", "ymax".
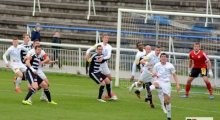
[{"xmin": 154, "ymin": 80, "xmax": 171, "ymax": 97}]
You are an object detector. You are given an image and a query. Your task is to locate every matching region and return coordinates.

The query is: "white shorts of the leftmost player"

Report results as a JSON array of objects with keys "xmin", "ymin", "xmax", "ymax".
[{"xmin": 10, "ymin": 62, "xmax": 27, "ymax": 73}]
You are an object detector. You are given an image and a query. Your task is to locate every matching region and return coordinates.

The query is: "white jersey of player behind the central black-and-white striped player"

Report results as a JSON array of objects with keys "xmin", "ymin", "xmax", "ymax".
[{"xmin": 86, "ymin": 42, "xmax": 112, "ymax": 60}]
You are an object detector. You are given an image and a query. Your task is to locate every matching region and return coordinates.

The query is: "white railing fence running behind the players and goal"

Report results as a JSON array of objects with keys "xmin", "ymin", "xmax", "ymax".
[{"xmin": 0, "ymin": 39, "xmax": 220, "ymax": 94}]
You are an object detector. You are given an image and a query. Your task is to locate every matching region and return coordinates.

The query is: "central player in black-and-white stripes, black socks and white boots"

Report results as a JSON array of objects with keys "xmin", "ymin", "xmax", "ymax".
[{"xmin": 88, "ymin": 45, "xmax": 117, "ymax": 102}]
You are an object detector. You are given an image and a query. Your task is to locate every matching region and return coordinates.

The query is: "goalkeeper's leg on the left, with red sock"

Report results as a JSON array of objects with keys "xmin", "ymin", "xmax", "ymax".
[{"xmin": 181, "ymin": 68, "xmax": 201, "ymax": 98}]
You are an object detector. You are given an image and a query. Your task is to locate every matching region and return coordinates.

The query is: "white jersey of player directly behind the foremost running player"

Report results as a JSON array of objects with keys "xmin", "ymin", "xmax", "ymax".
[{"xmin": 142, "ymin": 51, "xmax": 160, "ymax": 73}]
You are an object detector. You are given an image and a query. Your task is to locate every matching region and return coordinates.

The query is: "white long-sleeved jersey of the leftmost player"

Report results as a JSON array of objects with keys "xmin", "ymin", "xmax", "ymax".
[{"xmin": 3, "ymin": 45, "xmax": 28, "ymax": 64}]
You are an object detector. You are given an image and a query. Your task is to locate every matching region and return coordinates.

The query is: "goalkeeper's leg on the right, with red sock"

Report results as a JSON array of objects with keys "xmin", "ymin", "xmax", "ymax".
[{"xmin": 201, "ymin": 68, "xmax": 214, "ymax": 100}]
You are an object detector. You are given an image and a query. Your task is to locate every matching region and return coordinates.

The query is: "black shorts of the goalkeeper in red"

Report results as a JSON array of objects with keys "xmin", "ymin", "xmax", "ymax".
[{"xmin": 189, "ymin": 68, "xmax": 208, "ymax": 77}]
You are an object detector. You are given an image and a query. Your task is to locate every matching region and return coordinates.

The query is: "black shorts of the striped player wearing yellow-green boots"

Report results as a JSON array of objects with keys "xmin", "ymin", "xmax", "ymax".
[{"xmin": 26, "ymin": 69, "xmax": 43, "ymax": 85}]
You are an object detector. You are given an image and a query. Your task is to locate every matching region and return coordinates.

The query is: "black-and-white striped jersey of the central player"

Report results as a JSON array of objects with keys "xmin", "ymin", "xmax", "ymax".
[{"xmin": 88, "ymin": 53, "xmax": 106, "ymax": 73}]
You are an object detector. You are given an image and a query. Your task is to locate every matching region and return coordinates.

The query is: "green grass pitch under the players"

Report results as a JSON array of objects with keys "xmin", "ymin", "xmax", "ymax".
[{"xmin": 0, "ymin": 70, "xmax": 220, "ymax": 120}]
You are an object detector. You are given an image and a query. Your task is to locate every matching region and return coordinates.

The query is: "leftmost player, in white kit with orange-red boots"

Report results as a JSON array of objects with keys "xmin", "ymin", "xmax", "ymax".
[{"xmin": 3, "ymin": 38, "xmax": 28, "ymax": 92}]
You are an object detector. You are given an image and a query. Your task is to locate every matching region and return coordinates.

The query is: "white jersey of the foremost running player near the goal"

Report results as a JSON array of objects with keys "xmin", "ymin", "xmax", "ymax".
[{"xmin": 153, "ymin": 62, "xmax": 176, "ymax": 82}]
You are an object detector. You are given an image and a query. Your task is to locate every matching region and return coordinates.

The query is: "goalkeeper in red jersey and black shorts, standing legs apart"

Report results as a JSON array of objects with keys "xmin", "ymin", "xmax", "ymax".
[{"xmin": 181, "ymin": 43, "xmax": 214, "ymax": 100}]
